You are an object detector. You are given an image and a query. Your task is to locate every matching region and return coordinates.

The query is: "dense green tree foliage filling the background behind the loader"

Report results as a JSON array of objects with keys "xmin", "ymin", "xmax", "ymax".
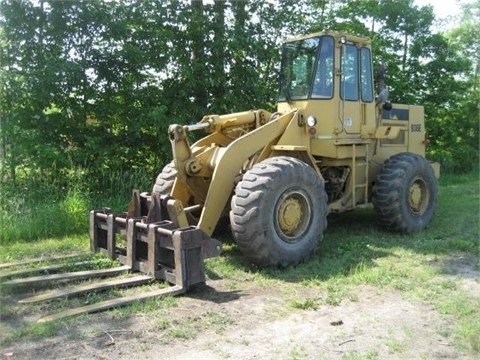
[{"xmin": 0, "ymin": 0, "xmax": 480, "ymax": 183}]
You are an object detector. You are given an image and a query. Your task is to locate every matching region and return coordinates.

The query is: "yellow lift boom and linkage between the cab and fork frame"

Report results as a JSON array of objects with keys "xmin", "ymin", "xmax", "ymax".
[{"xmin": 169, "ymin": 110, "xmax": 307, "ymax": 236}]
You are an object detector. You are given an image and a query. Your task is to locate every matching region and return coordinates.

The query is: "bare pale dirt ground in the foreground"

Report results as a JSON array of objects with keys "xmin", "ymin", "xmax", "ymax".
[{"xmin": 0, "ymin": 255, "xmax": 480, "ymax": 360}]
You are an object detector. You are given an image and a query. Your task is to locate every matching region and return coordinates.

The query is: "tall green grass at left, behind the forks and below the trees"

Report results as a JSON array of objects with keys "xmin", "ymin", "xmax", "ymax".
[{"xmin": 0, "ymin": 169, "xmax": 153, "ymax": 244}]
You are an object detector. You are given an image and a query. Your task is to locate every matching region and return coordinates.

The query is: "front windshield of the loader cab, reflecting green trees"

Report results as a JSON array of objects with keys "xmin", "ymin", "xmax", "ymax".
[{"xmin": 279, "ymin": 36, "xmax": 334, "ymax": 101}]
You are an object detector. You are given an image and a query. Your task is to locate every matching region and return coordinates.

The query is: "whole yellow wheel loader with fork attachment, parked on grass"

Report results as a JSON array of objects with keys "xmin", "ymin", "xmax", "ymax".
[{"xmin": 2, "ymin": 32, "xmax": 439, "ymax": 320}]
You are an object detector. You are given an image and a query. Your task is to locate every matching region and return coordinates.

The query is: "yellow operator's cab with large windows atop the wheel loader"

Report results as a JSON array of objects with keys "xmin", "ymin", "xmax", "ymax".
[{"xmin": 278, "ymin": 32, "xmax": 375, "ymax": 142}]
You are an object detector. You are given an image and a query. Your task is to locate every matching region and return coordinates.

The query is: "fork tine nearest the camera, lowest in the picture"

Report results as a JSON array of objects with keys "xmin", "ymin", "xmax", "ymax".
[{"xmin": 37, "ymin": 285, "xmax": 187, "ymax": 323}]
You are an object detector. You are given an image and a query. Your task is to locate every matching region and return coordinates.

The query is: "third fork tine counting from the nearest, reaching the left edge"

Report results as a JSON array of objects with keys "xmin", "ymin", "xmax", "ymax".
[{"xmin": 3, "ymin": 266, "xmax": 131, "ymax": 286}]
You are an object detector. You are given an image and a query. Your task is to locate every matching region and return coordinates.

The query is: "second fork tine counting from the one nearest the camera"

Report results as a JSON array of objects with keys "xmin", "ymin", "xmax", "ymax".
[{"xmin": 18, "ymin": 275, "xmax": 152, "ymax": 304}]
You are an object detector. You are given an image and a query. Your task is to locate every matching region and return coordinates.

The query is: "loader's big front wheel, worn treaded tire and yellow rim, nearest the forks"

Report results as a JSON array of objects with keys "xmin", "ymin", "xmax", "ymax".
[{"xmin": 230, "ymin": 156, "xmax": 328, "ymax": 266}]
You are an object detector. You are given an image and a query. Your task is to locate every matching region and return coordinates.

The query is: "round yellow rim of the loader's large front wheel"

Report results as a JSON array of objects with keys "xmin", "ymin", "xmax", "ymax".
[{"xmin": 275, "ymin": 189, "xmax": 312, "ymax": 243}]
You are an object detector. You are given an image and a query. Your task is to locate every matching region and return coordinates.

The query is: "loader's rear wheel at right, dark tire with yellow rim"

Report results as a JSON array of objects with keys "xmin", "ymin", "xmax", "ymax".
[{"xmin": 372, "ymin": 153, "xmax": 438, "ymax": 233}]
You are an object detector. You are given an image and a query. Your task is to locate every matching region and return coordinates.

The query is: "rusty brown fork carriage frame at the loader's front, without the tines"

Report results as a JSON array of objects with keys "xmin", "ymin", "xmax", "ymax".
[{"xmin": 90, "ymin": 190, "xmax": 221, "ymax": 289}]
